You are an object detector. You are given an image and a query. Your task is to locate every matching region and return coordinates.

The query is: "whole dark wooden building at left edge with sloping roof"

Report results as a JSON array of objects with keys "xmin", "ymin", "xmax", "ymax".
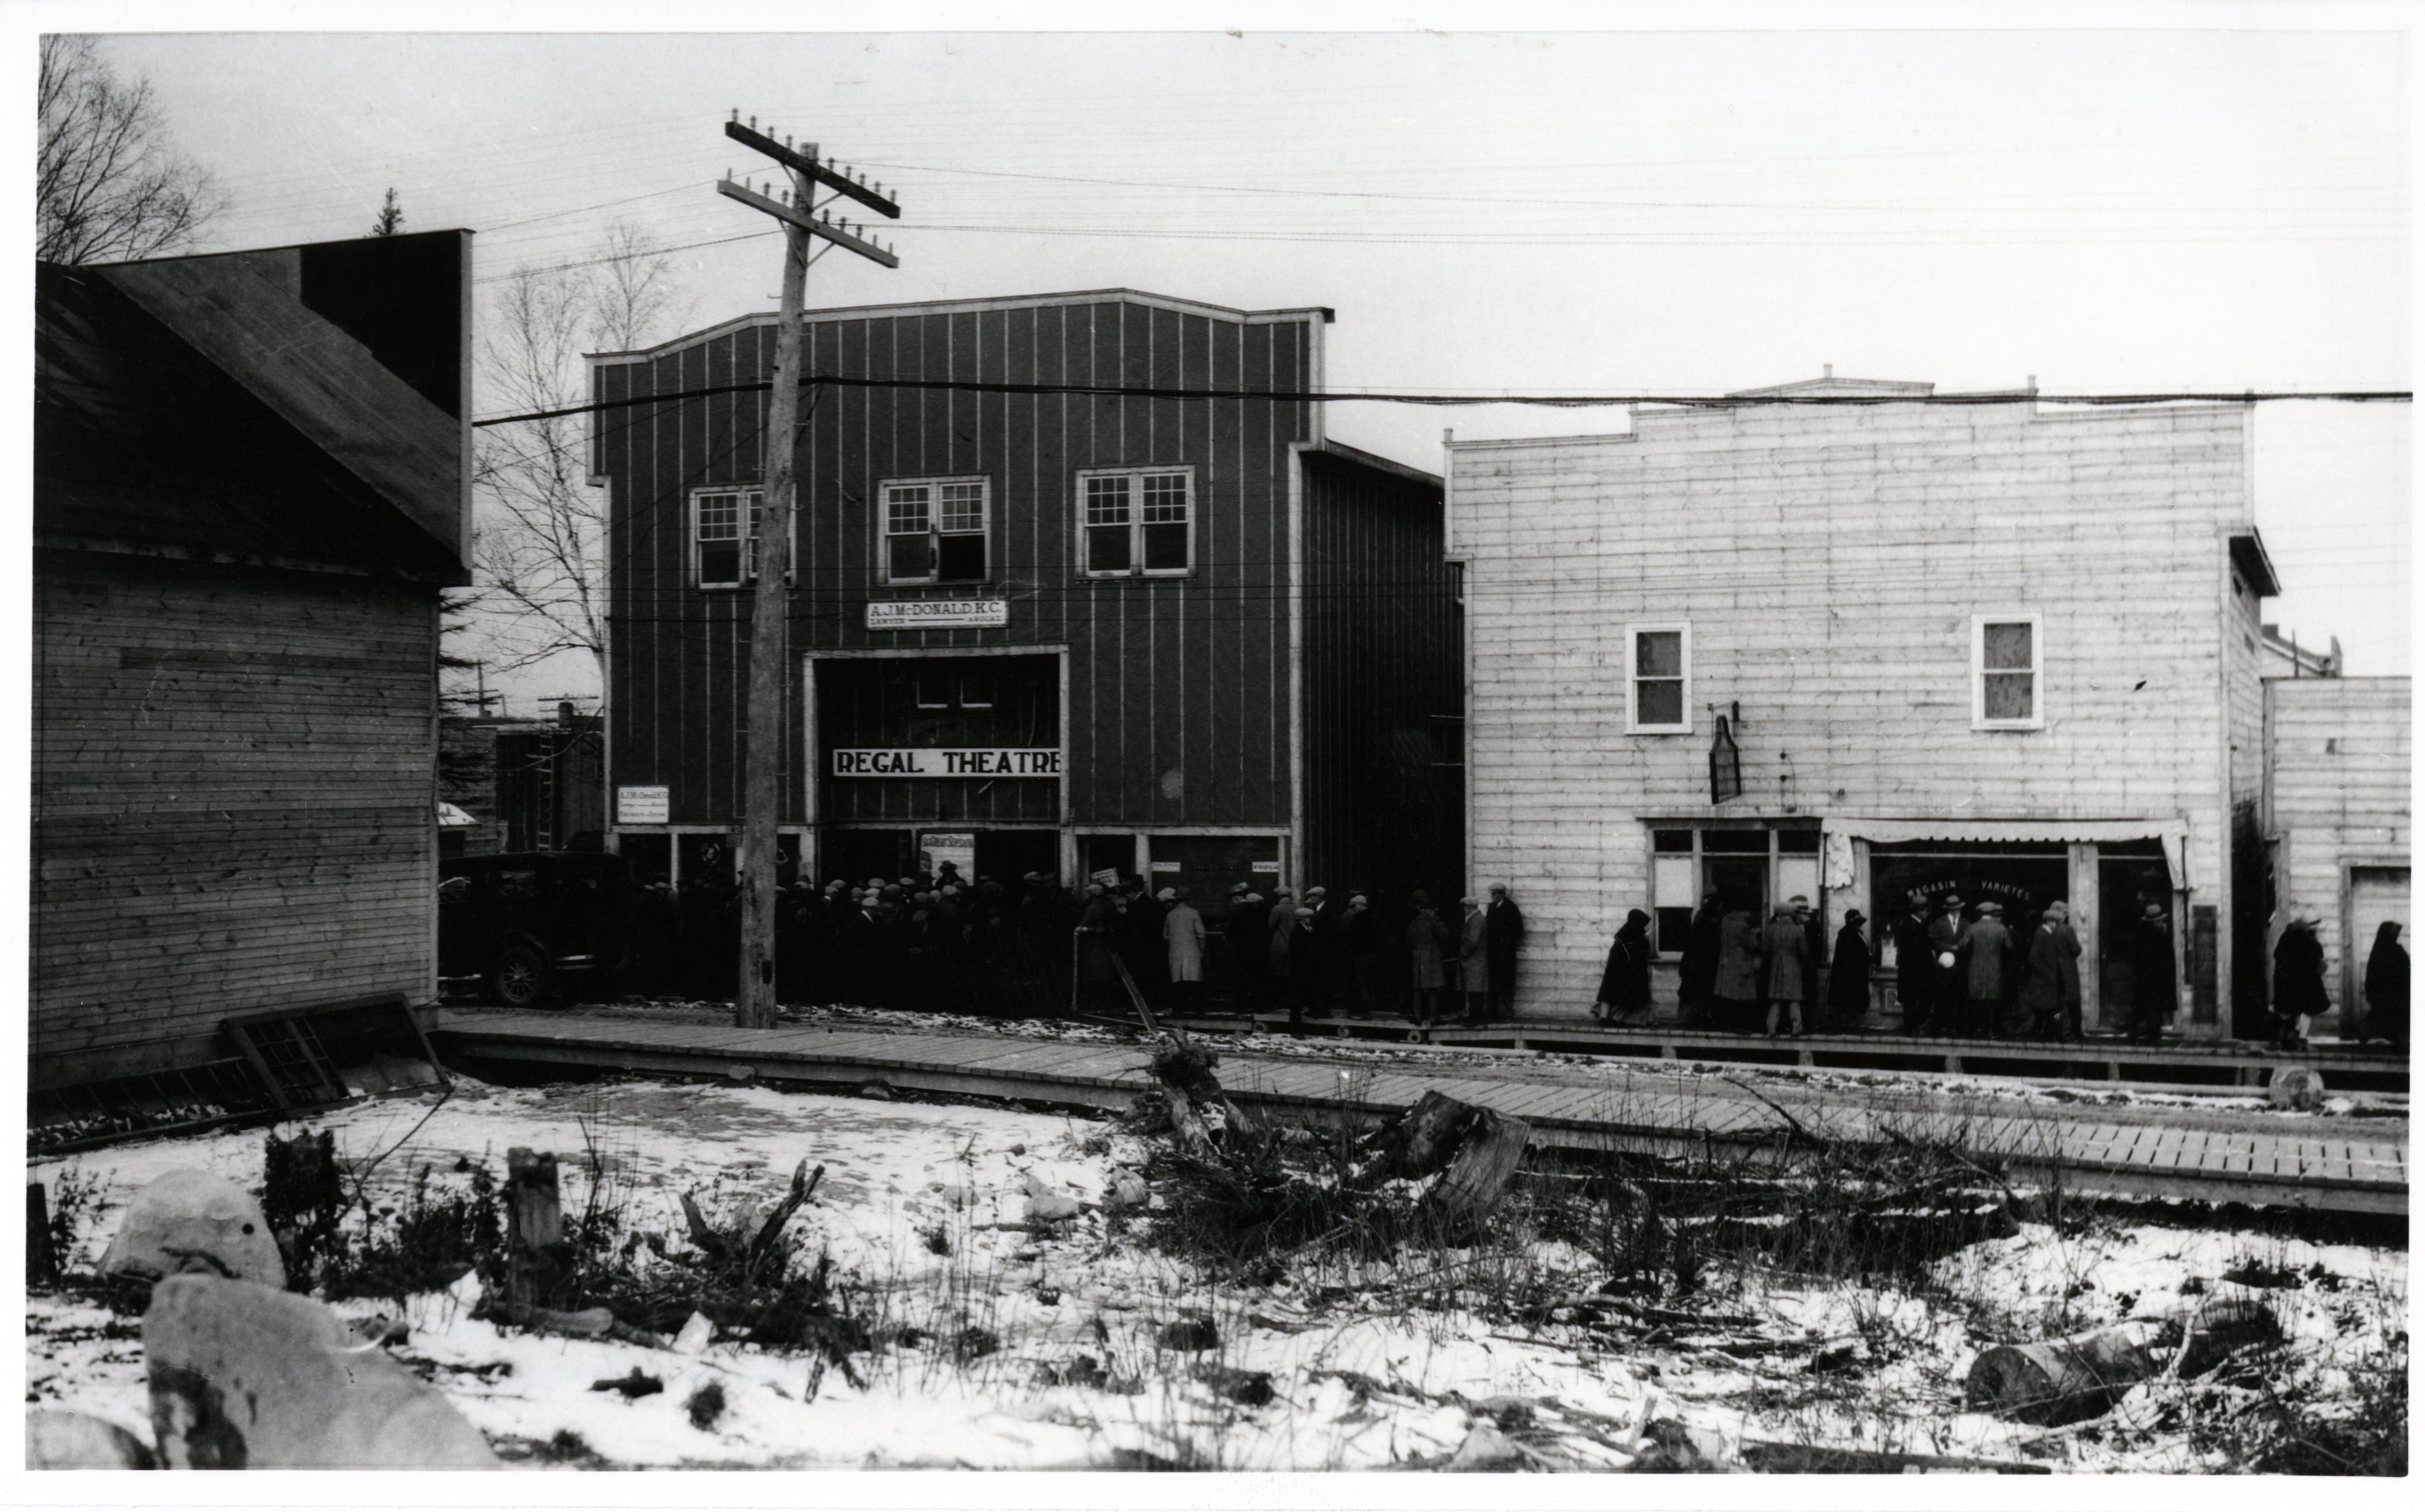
[{"xmin": 31, "ymin": 233, "xmax": 470, "ymax": 1088}]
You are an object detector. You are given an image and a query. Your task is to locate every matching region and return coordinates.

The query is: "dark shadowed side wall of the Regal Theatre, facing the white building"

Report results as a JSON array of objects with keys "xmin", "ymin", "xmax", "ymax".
[{"xmin": 1302, "ymin": 453, "xmax": 1465, "ymax": 901}]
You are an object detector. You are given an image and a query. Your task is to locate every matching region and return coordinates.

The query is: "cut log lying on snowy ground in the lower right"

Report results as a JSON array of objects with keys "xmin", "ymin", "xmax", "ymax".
[{"xmin": 1964, "ymin": 1299, "xmax": 2282, "ymax": 1427}]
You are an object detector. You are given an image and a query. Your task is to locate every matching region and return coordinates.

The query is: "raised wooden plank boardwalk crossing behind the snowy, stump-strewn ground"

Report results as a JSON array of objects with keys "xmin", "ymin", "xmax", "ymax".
[{"xmin": 432, "ymin": 1010, "xmax": 2408, "ymax": 1214}]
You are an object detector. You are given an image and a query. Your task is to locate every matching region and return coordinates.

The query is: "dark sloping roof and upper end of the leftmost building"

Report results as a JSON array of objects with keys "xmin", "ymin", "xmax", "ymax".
[{"xmin": 34, "ymin": 233, "xmax": 468, "ymax": 581}]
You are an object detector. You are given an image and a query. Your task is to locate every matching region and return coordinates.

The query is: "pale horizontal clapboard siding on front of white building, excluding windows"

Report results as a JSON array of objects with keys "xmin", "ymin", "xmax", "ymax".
[{"xmin": 1450, "ymin": 405, "xmax": 2253, "ymax": 1013}]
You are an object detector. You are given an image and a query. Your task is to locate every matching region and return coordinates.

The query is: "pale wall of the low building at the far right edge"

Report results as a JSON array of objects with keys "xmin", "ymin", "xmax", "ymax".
[{"xmin": 2265, "ymin": 678, "xmax": 2415, "ymax": 1008}]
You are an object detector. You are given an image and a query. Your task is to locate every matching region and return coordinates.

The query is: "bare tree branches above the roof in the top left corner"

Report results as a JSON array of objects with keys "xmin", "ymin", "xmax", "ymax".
[{"xmin": 34, "ymin": 36, "xmax": 228, "ymax": 262}]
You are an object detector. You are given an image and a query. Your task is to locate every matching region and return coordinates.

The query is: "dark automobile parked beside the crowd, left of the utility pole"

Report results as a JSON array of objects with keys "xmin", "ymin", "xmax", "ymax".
[{"xmin": 439, "ymin": 850, "xmax": 630, "ymax": 1008}]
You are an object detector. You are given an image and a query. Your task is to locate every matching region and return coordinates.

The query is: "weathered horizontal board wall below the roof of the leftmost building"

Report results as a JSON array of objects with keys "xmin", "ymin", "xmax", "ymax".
[{"xmin": 31, "ymin": 552, "xmax": 437, "ymax": 1081}]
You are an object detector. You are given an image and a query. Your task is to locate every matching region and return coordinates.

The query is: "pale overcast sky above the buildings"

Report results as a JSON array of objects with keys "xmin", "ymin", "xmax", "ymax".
[{"xmin": 36, "ymin": 7, "xmax": 2410, "ymax": 695}]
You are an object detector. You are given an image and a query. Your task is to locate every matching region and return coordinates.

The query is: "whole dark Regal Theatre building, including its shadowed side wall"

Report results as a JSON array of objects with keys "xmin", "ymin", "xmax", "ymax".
[{"xmin": 592, "ymin": 291, "xmax": 1462, "ymax": 916}]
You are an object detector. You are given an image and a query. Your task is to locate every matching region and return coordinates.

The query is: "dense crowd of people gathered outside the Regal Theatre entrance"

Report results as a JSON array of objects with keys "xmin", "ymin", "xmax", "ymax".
[{"xmin": 596, "ymin": 860, "xmax": 1523, "ymax": 1023}]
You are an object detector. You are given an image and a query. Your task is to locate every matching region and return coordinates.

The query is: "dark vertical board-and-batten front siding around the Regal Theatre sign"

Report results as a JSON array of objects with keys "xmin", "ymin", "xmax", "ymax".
[{"xmin": 594, "ymin": 296, "xmax": 1314, "ymax": 829}]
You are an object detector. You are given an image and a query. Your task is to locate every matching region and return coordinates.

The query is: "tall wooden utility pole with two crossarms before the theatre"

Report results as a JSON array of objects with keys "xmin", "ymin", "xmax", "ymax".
[{"xmin": 715, "ymin": 112, "xmax": 900, "ymax": 1030}]
